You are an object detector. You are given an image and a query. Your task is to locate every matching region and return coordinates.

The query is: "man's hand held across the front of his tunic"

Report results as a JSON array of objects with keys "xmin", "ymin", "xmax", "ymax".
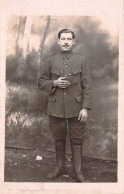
[{"xmin": 53, "ymin": 77, "xmax": 70, "ymax": 88}]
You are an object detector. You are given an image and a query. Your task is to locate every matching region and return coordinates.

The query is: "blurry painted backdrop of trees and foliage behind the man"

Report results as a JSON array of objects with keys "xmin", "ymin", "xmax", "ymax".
[{"xmin": 5, "ymin": 16, "xmax": 118, "ymax": 160}]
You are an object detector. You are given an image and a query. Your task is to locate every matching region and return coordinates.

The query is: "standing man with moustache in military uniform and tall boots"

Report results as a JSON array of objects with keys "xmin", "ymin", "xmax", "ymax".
[{"xmin": 38, "ymin": 29, "xmax": 91, "ymax": 182}]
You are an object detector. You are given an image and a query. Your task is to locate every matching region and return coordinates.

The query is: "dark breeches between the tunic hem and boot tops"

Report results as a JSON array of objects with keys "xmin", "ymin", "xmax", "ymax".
[{"xmin": 49, "ymin": 115, "xmax": 85, "ymax": 145}]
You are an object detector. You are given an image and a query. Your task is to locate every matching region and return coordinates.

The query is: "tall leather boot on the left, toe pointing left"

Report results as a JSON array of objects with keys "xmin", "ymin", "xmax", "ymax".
[{"xmin": 47, "ymin": 140, "xmax": 65, "ymax": 180}]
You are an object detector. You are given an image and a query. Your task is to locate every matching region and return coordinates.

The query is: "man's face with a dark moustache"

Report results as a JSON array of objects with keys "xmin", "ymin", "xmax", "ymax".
[{"xmin": 58, "ymin": 32, "xmax": 75, "ymax": 51}]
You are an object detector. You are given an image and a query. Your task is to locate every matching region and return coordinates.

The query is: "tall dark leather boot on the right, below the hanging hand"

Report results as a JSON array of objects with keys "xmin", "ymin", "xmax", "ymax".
[{"xmin": 71, "ymin": 144, "xmax": 89, "ymax": 182}]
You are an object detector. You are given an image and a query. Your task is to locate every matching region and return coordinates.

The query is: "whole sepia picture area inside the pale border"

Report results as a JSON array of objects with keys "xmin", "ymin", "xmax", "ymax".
[{"xmin": 5, "ymin": 15, "xmax": 119, "ymax": 182}]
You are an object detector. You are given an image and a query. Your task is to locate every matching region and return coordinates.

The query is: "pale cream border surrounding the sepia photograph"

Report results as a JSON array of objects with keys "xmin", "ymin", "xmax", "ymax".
[{"xmin": 0, "ymin": 0, "xmax": 124, "ymax": 194}]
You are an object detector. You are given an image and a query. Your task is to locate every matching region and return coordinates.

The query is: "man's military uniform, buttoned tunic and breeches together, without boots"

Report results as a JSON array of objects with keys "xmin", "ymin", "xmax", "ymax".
[{"xmin": 38, "ymin": 51, "xmax": 91, "ymax": 182}]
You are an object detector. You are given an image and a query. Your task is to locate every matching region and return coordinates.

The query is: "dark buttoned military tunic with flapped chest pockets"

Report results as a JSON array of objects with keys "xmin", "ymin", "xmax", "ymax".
[{"xmin": 38, "ymin": 51, "xmax": 91, "ymax": 118}]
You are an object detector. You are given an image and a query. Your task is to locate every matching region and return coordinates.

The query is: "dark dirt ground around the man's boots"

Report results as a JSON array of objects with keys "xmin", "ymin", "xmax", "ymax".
[{"xmin": 4, "ymin": 148, "xmax": 117, "ymax": 182}]
